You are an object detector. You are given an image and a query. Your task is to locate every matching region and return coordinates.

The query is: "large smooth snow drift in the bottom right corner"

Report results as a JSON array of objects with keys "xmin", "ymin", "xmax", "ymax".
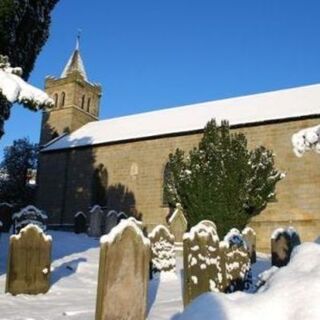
[{"xmin": 178, "ymin": 243, "xmax": 320, "ymax": 320}]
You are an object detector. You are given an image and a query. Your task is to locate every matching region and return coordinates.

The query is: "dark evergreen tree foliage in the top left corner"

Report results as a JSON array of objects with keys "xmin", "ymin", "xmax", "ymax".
[{"xmin": 0, "ymin": 0, "xmax": 58, "ymax": 138}]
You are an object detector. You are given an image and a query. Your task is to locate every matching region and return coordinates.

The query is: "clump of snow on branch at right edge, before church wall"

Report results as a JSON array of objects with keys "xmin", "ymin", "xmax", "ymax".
[{"xmin": 291, "ymin": 125, "xmax": 320, "ymax": 157}]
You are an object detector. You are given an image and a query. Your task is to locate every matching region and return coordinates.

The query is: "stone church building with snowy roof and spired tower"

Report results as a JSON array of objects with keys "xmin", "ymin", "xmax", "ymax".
[{"xmin": 37, "ymin": 43, "xmax": 320, "ymax": 250}]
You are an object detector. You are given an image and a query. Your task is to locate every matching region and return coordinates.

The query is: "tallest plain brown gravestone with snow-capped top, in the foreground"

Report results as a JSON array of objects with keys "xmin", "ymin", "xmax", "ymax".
[{"xmin": 95, "ymin": 218, "xmax": 150, "ymax": 320}]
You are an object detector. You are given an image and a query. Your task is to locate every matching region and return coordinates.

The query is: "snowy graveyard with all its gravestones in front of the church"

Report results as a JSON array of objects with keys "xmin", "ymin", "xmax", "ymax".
[{"xmin": 0, "ymin": 206, "xmax": 320, "ymax": 320}]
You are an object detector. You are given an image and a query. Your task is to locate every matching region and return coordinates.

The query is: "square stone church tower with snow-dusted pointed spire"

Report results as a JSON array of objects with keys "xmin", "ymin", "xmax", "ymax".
[{"xmin": 40, "ymin": 37, "xmax": 101, "ymax": 145}]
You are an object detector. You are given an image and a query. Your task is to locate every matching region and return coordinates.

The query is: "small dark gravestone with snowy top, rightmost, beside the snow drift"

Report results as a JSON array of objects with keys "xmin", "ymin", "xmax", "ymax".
[{"xmin": 271, "ymin": 227, "xmax": 301, "ymax": 267}]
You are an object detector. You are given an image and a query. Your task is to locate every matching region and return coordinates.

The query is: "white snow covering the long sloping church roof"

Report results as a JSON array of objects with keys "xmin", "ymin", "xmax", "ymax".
[{"xmin": 43, "ymin": 84, "xmax": 320, "ymax": 151}]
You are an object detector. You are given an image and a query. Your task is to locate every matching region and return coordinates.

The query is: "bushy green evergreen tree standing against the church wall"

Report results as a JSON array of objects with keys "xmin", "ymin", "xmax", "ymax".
[{"xmin": 164, "ymin": 120, "xmax": 282, "ymax": 236}]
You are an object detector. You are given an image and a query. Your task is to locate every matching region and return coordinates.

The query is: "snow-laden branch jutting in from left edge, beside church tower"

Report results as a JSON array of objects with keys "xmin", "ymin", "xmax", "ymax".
[{"xmin": 0, "ymin": 55, "xmax": 54, "ymax": 109}]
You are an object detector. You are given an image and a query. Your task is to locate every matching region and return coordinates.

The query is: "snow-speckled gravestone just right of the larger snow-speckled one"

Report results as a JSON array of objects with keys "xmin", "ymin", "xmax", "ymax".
[{"xmin": 220, "ymin": 228, "xmax": 251, "ymax": 292}]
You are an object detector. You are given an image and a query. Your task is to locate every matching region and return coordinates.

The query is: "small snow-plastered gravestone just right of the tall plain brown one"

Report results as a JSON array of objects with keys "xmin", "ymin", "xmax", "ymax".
[{"xmin": 148, "ymin": 225, "xmax": 176, "ymax": 273}]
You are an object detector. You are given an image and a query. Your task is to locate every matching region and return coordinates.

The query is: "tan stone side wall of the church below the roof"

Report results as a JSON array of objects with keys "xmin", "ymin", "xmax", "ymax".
[{"xmin": 39, "ymin": 119, "xmax": 320, "ymax": 250}]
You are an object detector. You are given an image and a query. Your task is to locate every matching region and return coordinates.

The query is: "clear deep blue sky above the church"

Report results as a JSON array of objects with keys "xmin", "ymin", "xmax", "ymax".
[{"xmin": 0, "ymin": 0, "xmax": 320, "ymax": 157}]
